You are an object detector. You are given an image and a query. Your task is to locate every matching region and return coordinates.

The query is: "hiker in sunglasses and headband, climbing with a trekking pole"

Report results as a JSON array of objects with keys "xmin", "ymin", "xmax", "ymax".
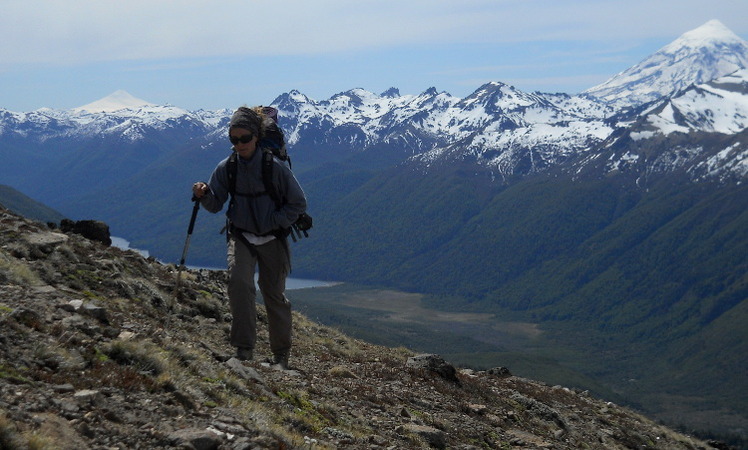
[{"xmin": 192, "ymin": 107, "xmax": 306, "ymax": 370}]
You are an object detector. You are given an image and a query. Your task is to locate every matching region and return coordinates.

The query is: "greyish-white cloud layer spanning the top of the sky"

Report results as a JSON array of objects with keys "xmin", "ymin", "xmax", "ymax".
[{"xmin": 0, "ymin": 0, "xmax": 748, "ymax": 66}]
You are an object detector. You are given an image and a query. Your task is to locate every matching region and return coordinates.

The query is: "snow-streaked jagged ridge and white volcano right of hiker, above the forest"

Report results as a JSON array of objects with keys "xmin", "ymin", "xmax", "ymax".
[{"xmin": 262, "ymin": 20, "xmax": 748, "ymax": 183}]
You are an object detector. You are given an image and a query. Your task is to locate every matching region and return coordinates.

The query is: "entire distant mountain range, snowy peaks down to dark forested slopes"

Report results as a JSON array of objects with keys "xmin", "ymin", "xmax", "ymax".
[{"xmin": 0, "ymin": 21, "xmax": 748, "ymax": 442}]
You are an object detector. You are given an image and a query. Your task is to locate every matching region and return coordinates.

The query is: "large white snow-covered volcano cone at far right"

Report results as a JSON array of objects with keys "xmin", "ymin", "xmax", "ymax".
[{"xmin": 584, "ymin": 20, "xmax": 748, "ymax": 108}]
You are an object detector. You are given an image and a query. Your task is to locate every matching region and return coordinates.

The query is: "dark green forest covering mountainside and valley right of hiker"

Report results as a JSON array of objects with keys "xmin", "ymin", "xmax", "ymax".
[{"xmin": 284, "ymin": 165, "xmax": 748, "ymax": 442}]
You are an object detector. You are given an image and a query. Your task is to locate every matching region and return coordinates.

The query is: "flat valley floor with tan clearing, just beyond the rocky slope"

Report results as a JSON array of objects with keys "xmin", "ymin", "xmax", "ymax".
[{"xmin": 289, "ymin": 284, "xmax": 748, "ymax": 446}]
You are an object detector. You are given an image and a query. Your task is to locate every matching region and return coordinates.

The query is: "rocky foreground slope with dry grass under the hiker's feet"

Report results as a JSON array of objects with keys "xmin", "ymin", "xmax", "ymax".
[{"xmin": 0, "ymin": 209, "xmax": 718, "ymax": 449}]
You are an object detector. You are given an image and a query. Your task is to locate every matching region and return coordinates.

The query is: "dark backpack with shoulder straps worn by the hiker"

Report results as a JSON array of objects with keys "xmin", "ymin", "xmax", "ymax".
[{"xmin": 226, "ymin": 106, "xmax": 312, "ymax": 242}]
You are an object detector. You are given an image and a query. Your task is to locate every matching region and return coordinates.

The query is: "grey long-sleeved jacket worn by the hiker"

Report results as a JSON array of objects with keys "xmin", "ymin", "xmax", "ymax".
[{"xmin": 200, "ymin": 147, "xmax": 306, "ymax": 236}]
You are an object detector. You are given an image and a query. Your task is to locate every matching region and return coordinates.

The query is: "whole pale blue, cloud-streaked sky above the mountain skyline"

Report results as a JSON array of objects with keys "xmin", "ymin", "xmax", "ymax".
[{"xmin": 0, "ymin": 0, "xmax": 748, "ymax": 112}]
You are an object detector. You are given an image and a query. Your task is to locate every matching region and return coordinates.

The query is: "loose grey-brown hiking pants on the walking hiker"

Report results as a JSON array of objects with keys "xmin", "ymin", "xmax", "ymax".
[{"xmin": 227, "ymin": 235, "xmax": 291, "ymax": 355}]
